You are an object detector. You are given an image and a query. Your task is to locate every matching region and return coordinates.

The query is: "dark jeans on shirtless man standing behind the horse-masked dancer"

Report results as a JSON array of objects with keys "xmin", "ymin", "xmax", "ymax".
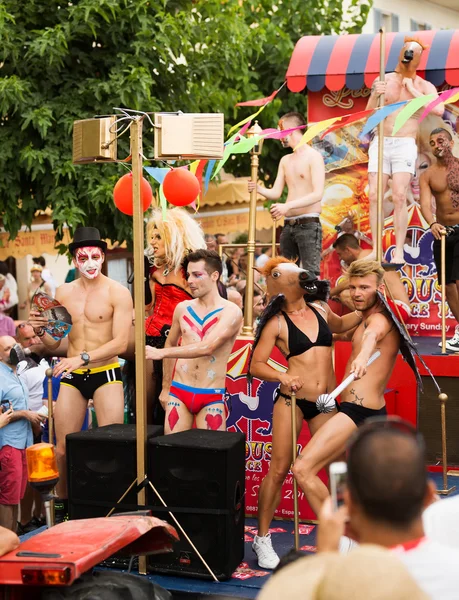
[{"xmin": 280, "ymin": 219, "xmax": 322, "ymax": 277}]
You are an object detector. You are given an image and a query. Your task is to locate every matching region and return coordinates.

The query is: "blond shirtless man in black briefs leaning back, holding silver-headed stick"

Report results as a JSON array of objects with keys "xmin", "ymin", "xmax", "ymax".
[{"xmin": 293, "ymin": 260, "xmax": 400, "ymax": 514}]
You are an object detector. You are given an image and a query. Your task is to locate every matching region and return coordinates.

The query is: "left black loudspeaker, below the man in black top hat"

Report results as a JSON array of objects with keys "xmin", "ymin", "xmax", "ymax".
[{"xmin": 66, "ymin": 424, "xmax": 163, "ymax": 519}]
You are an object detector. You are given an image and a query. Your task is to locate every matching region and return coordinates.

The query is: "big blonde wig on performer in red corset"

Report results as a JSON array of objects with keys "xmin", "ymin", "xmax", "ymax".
[{"xmin": 147, "ymin": 207, "xmax": 207, "ymax": 273}]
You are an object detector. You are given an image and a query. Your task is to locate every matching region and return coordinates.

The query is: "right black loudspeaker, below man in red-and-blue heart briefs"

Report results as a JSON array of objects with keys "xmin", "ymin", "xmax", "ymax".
[{"xmin": 147, "ymin": 429, "xmax": 245, "ymax": 579}]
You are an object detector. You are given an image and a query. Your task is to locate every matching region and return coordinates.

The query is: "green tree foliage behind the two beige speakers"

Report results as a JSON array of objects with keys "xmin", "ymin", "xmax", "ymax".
[{"xmin": 0, "ymin": 0, "xmax": 371, "ymax": 247}]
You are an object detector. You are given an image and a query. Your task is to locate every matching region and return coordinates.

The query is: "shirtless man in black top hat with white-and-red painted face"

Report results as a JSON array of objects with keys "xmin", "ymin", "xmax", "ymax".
[{"xmin": 29, "ymin": 227, "xmax": 132, "ymax": 520}]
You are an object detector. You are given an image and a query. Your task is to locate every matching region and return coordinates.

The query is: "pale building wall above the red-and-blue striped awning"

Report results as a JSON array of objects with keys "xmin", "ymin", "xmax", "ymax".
[{"xmin": 362, "ymin": 0, "xmax": 459, "ymax": 33}]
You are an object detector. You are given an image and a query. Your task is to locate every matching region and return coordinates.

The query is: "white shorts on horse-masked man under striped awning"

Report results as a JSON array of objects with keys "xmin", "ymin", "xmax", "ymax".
[{"xmin": 368, "ymin": 136, "xmax": 418, "ymax": 175}]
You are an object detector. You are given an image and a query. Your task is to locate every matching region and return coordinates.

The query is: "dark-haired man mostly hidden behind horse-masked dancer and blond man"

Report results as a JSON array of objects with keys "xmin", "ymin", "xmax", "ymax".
[{"xmin": 330, "ymin": 233, "xmax": 411, "ymax": 323}]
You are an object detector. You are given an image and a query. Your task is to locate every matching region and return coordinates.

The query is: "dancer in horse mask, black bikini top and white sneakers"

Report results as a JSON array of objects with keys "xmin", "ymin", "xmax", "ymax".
[{"xmin": 250, "ymin": 257, "xmax": 361, "ymax": 569}]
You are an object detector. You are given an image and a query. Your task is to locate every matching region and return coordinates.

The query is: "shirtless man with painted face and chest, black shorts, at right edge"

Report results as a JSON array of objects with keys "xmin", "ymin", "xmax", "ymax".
[{"xmin": 420, "ymin": 128, "xmax": 459, "ymax": 352}]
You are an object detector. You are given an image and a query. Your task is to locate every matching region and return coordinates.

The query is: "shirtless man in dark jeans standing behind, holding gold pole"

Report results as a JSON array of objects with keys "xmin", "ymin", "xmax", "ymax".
[{"xmin": 249, "ymin": 113, "xmax": 325, "ymax": 277}]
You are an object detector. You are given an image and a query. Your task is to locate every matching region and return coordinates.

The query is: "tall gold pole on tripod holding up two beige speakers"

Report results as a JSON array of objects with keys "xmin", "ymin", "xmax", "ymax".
[{"xmin": 131, "ymin": 117, "xmax": 147, "ymax": 575}]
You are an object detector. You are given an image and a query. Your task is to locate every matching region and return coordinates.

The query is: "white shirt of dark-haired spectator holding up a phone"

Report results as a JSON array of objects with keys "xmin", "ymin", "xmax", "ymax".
[{"xmin": 392, "ymin": 538, "xmax": 459, "ymax": 600}]
